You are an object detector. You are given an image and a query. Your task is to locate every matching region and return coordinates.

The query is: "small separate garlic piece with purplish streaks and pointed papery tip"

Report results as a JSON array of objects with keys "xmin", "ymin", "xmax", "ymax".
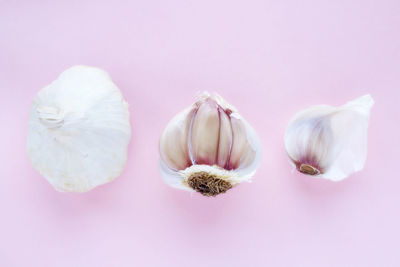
[{"xmin": 285, "ymin": 95, "xmax": 374, "ymax": 181}]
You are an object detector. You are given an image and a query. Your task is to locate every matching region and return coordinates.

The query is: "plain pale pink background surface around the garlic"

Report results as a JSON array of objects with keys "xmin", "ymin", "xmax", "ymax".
[{"xmin": 0, "ymin": 0, "xmax": 400, "ymax": 267}]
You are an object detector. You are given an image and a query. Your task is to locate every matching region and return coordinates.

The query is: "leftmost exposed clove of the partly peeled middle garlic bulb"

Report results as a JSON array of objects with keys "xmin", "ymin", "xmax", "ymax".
[{"xmin": 160, "ymin": 108, "xmax": 196, "ymax": 170}]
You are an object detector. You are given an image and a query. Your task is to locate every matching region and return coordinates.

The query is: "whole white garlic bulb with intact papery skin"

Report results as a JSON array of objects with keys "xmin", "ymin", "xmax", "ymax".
[{"xmin": 27, "ymin": 66, "xmax": 131, "ymax": 192}]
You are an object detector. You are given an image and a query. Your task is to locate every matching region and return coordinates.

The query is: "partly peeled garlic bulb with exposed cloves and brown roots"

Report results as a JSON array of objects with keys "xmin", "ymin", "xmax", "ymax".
[{"xmin": 160, "ymin": 93, "xmax": 261, "ymax": 196}]
